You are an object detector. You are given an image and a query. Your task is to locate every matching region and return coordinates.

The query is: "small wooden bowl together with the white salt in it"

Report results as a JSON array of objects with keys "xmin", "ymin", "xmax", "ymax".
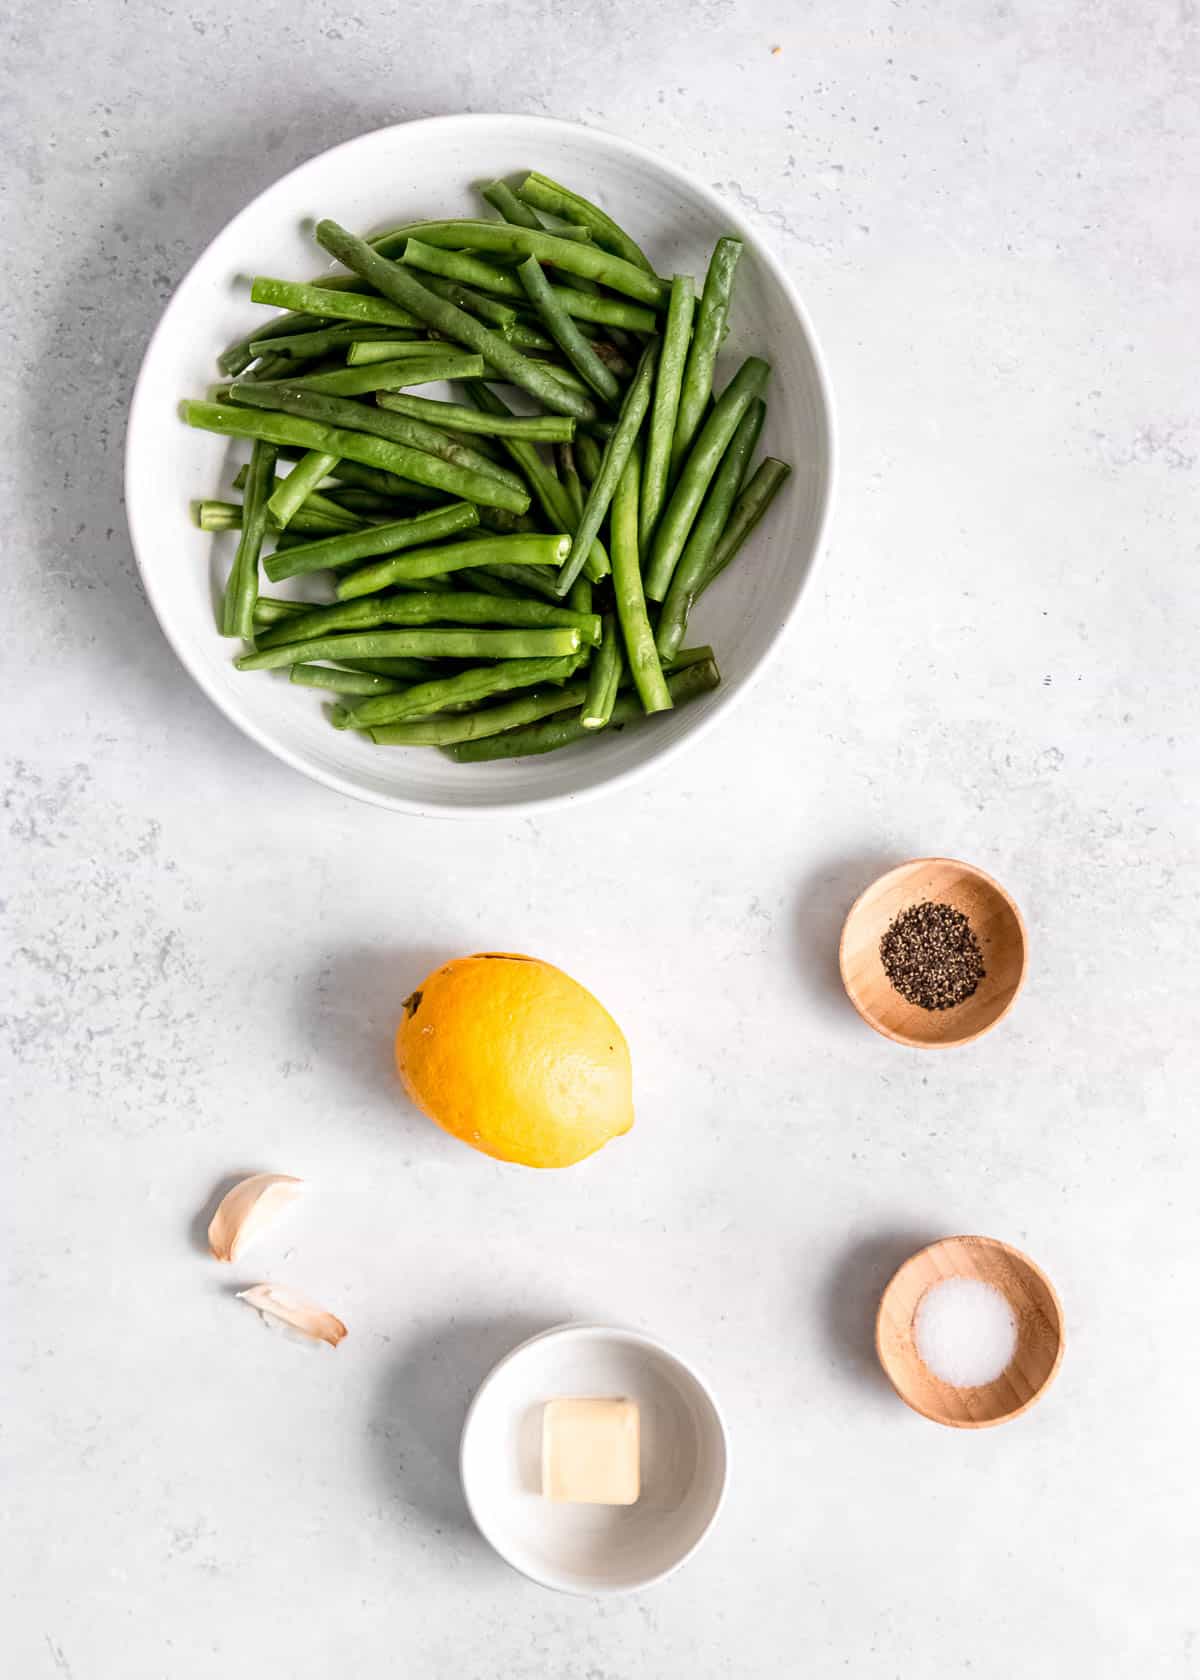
[{"xmin": 876, "ymin": 1236, "xmax": 1064, "ymax": 1430}]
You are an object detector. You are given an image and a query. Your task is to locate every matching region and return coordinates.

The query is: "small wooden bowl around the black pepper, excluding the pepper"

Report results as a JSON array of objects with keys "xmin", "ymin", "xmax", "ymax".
[{"xmin": 839, "ymin": 857, "xmax": 1025, "ymax": 1050}]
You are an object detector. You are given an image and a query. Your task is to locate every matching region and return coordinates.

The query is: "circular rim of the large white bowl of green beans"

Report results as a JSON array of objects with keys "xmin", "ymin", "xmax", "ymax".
[{"xmin": 124, "ymin": 111, "xmax": 837, "ymax": 818}]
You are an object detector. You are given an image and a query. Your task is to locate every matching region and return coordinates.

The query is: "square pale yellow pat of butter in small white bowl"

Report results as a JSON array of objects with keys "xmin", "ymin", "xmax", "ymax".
[{"xmin": 541, "ymin": 1399, "xmax": 642, "ymax": 1505}]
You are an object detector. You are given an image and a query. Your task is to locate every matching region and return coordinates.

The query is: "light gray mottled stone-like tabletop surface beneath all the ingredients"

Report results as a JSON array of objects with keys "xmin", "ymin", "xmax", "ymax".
[{"xmin": 0, "ymin": 0, "xmax": 1200, "ymax": 1680}]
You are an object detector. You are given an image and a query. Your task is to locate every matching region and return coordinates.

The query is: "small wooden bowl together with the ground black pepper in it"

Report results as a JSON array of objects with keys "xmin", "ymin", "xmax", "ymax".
[{"xmin": 839, "ymin": 857, "xmax": 1025, "ymax": 1050}]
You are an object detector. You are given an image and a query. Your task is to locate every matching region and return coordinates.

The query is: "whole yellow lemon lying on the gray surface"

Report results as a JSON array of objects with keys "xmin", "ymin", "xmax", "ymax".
[{"xmin": 397, "ymin": 951, "xmax": 634, "ymax": 1166}]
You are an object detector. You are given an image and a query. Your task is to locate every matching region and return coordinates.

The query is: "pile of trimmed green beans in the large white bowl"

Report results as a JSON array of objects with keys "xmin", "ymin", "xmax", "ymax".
[{"xmin": 180, "ymin": 171, "xmax": 790, "ymax": 763}]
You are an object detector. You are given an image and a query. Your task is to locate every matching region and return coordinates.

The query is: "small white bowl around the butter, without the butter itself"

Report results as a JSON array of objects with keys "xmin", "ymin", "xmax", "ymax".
[{"xmin": 459, "ymin": 1324, "xmax": 728, "ymax": 1594}]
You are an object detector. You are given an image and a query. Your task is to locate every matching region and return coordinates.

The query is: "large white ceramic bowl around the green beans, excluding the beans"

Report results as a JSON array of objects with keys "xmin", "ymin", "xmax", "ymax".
[{"xmin": 126, "ymin": 116, "xmax": 832, "ymax": 816}]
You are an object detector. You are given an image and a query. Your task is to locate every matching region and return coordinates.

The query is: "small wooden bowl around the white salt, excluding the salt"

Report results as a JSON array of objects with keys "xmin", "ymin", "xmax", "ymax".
[{"xmin": 876, "ymin": 1236, "xmax": 1064, "ymax": 1430}]
